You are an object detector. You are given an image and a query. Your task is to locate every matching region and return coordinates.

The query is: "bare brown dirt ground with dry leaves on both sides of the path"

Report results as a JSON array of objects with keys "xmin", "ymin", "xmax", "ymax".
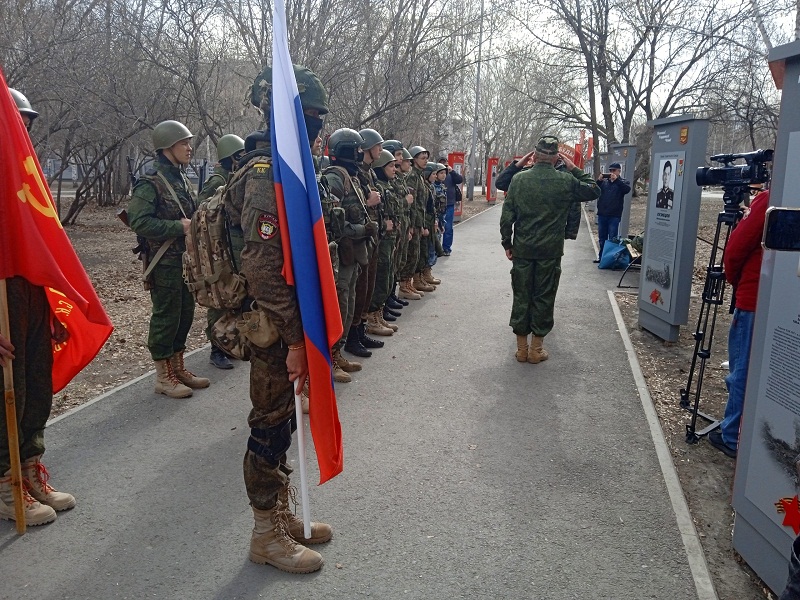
[{"xmin": 53, "ymin": 194, "xmax": 774, "ymax": 600}]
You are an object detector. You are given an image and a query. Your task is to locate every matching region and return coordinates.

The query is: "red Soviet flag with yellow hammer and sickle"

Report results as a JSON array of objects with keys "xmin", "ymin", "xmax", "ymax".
[{"xmin": 0, "ymin": 71, "xmax": 114, "ymax": 392}]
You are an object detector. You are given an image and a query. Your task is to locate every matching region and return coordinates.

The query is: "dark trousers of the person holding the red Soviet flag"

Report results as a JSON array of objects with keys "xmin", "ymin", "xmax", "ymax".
[{"xmin": 0, "ymin": 277, "xmax": 52, "ymax": 477}]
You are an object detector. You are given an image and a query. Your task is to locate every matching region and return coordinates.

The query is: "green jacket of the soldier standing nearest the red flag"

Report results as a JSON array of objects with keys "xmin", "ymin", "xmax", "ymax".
[{"xmin": 128, "ymin": 154, "xmax": 195, "ymax": 265}]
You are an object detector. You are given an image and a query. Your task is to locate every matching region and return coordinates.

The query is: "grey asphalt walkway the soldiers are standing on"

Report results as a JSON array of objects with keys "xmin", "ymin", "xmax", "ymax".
[{"xmin": 0, "ymin": 207, "xmax": 714, "ymax": 600}]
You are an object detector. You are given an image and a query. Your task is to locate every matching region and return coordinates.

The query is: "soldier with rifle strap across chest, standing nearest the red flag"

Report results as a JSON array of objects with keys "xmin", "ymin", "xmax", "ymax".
[{"xmin": 128, "ymin": 121, "xmax": 210, "ymax": 398}]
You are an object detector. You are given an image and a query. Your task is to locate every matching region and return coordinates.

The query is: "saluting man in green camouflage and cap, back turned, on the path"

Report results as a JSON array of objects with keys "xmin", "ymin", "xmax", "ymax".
[{"xmin": 500, "ymin": 136, "xmax": 600, "ymax": 364}]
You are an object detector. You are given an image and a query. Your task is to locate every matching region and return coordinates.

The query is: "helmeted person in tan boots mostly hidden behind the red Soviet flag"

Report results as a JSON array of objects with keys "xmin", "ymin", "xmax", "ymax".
[{"xmin": 0, "ymin": 88, "xmax": 75, "ymax": 525}]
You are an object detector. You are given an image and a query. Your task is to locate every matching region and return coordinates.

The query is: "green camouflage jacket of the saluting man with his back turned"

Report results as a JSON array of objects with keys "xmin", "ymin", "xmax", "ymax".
[{"xmin": 500, "ymin": 162, "xmax": 600, "ymax": 259}]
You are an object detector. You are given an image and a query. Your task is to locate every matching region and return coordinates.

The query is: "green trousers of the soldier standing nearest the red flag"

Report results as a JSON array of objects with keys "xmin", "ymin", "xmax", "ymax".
[{"xmin": 147, "ymin": 263, "xmax": 194, "ymax": 360}]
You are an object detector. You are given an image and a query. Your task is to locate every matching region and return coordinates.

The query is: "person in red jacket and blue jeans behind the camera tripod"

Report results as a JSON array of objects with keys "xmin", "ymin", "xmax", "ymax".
[{"xmin": 708, "ymin": 190, "xmax": 769, "ymax": 458}]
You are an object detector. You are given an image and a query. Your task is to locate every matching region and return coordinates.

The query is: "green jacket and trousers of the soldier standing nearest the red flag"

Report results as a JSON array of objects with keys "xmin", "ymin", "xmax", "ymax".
[{"xmin": 128, "ymin": 154, "xmax": 195, "ymax": 361}]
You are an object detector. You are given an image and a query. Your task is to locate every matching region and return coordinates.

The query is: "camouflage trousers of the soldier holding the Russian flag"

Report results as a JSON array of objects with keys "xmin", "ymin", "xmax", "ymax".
[{"xmin": 243, "ymin": 343, "xmax": 294, "ymax": 510}]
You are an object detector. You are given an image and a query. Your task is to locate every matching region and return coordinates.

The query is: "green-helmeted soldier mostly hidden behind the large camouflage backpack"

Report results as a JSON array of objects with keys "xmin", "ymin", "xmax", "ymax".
[{"xmin": 197, "ymin": 133, "xmax": 244, "ymax": 369}]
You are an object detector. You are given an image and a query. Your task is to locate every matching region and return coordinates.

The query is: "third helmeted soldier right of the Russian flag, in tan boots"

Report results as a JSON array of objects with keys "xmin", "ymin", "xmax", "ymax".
[{"xmin": 367, "ymin": 150, "xmax": 405, "ymax": 335}]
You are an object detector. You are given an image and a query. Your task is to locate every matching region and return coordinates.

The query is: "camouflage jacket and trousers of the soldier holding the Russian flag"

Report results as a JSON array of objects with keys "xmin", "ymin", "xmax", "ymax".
[{"xmin": 226, "ymin": 141, "xmax": 304, "ymax": 510}]
